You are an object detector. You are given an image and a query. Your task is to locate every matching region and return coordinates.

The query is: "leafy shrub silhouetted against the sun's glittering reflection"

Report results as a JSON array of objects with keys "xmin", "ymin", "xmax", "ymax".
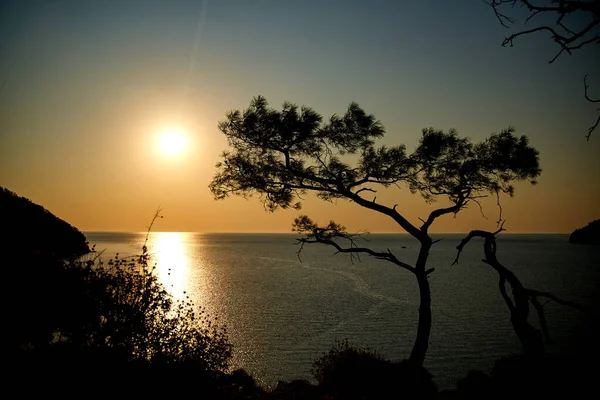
[{"xmin": 64, "ymin": 247, "xmax": 231, "ymax": 371}]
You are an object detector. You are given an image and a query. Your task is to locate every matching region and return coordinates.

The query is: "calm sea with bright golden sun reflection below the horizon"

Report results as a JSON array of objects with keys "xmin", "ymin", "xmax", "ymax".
[{"xmin": 85, "ymin": 232, "xmax": 600, "ymax": 388}]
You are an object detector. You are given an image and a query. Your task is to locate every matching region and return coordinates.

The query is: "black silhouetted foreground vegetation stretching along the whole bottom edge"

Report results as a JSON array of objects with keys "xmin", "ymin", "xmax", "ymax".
[{"xmin": 0, "ymin": 192, "xmax": 594, "ymax": 400}]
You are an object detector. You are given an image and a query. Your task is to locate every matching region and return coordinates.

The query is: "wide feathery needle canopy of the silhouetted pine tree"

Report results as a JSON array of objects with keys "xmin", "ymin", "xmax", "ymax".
[{"xmin": 210, "ymin": 96, "xmax": 541, "ymax": 237}]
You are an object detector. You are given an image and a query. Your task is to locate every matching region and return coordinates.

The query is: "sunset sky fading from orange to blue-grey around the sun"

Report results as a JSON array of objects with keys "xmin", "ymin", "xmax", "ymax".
[{"xmin": 0, "ymin": 0, "xmax": 600, "ymax": 233}]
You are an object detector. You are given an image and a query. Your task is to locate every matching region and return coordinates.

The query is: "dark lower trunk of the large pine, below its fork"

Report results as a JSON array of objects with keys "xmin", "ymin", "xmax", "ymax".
[{"xmin": 408, "ymin": 240, "xmax": 431, "ymax": 367}]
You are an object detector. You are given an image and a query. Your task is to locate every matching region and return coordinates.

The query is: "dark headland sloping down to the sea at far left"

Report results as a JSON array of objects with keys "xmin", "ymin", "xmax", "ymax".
[{"xmin": 0, "ymin": 186, "xmax": 90, "ymax": 258}]
